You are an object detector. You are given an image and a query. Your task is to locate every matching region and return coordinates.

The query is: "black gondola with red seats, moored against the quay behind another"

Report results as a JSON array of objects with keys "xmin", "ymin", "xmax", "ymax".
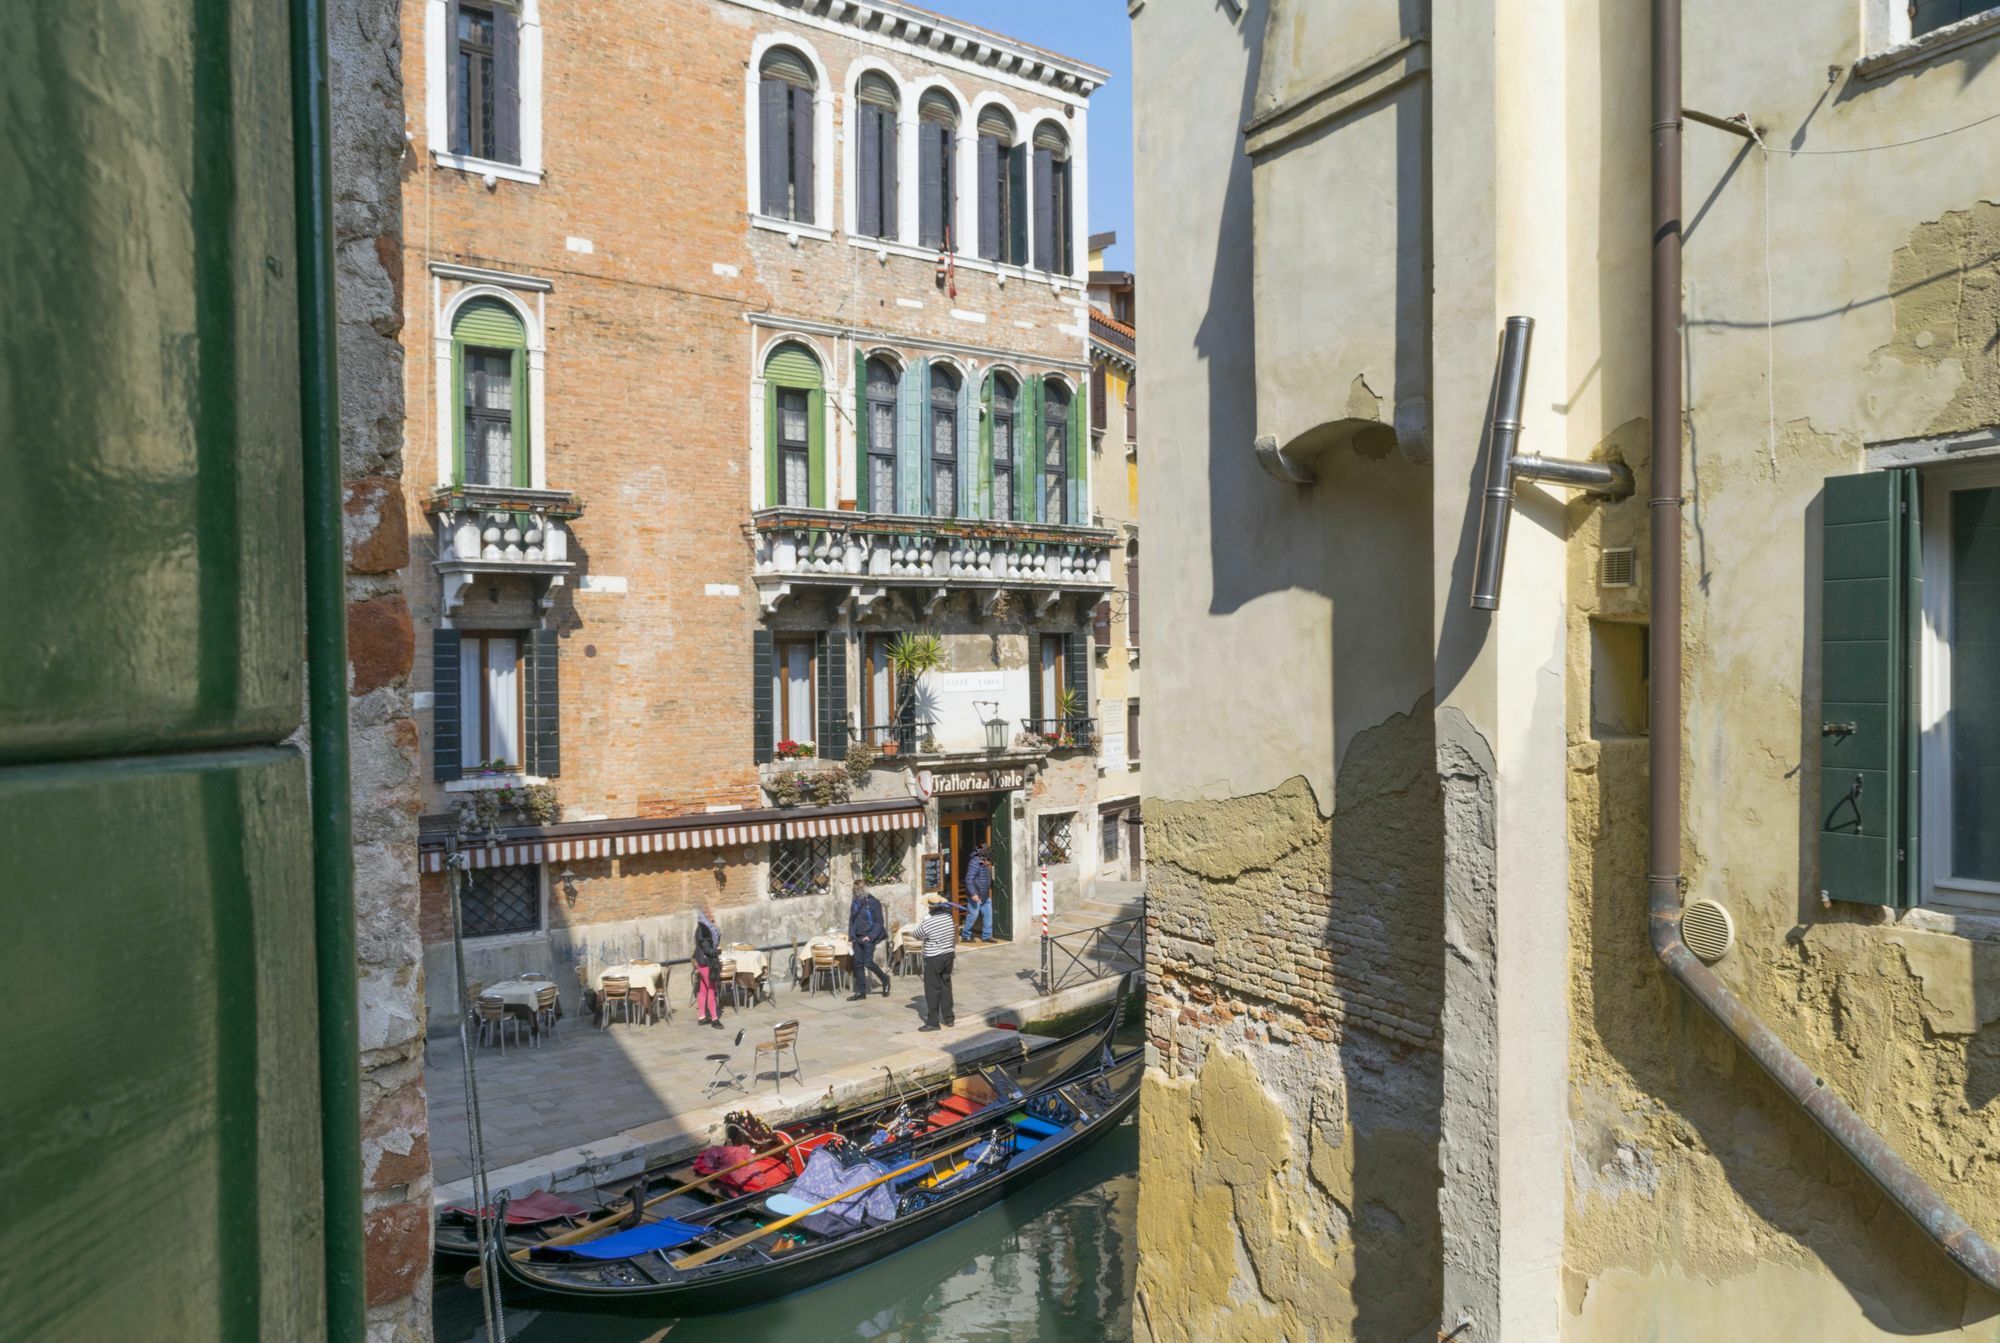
[{"xmin": 432, "ymin": 985, "xmax": 1124, "ymax": 1265}]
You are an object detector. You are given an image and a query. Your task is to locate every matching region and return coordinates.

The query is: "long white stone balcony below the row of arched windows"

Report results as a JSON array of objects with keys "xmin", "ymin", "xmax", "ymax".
[{"xmin": 750, "ymin": 508, "xmax": 1118, "ymax": 616}]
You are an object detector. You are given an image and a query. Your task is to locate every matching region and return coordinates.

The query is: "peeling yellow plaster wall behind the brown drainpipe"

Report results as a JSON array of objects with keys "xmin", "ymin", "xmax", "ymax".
[{"xmin": 1564, "ymin": 0, "xmax": 2000, "ymax": 1341}]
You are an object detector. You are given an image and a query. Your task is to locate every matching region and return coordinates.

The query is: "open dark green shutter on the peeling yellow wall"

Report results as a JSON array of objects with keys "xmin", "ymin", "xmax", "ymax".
[{"xmin": 1808, "ymin": 470, "xmax": 1922, "ymax": 905}]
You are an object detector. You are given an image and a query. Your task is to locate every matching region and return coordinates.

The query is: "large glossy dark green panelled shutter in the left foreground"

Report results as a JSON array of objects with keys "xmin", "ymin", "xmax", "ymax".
[{"xmin": 0, "ymin": 0, "xmax": 358, "ymax": 1343}]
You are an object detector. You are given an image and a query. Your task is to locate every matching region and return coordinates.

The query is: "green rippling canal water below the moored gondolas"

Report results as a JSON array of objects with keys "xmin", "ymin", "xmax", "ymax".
[{"xmin": 436, "ymin": 1119, "xmax": 1138, "ymax": 1343}]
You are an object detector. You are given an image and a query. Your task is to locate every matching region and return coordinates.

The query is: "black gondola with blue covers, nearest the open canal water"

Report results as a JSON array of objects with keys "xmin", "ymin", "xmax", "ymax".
[{"xmin": 482, "ymin": 1049, "xmax": 1144, "ymax": 1315}]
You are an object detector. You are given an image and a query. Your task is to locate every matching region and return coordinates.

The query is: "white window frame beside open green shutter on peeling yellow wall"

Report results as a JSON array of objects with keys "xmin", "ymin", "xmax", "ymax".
[{"xmin": 1918, "ymin": 458, "xmax": 2000, "ymax": 913}]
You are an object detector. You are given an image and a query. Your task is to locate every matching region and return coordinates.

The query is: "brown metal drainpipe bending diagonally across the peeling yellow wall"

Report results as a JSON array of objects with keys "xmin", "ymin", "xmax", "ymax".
[{"xmin": 1646, "ymin": 0, "xmax": 2000, "ymax": 1291}]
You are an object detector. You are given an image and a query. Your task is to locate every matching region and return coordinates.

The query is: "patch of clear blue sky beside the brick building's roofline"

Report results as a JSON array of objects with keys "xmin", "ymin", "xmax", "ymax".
[{"xmin": 922, "ymin": 0, "xmax": 1132, "ymax": 270}]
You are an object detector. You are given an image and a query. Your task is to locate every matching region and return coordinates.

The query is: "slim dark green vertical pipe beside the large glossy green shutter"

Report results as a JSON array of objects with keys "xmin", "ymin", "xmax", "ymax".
[{"xmin": 290, "ymin": 0, "xmax": 368, "ymax": 1343}]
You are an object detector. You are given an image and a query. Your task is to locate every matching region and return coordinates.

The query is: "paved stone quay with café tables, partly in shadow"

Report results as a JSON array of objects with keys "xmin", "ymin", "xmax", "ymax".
[{"xmin": 426, "ymin": 895, "xmax": 1144, "ymax": 1203}]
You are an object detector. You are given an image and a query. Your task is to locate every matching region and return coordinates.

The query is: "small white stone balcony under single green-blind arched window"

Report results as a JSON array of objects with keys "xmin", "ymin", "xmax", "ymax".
[{"xmin": 424, "ymin": 486, "xmax": 584, "ymax": 616}]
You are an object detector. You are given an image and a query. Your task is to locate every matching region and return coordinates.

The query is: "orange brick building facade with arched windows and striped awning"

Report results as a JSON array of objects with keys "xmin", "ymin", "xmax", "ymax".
[{"xmin": 402, "ymin": 0, "xmax": 1114, "ymax": 1023}]
